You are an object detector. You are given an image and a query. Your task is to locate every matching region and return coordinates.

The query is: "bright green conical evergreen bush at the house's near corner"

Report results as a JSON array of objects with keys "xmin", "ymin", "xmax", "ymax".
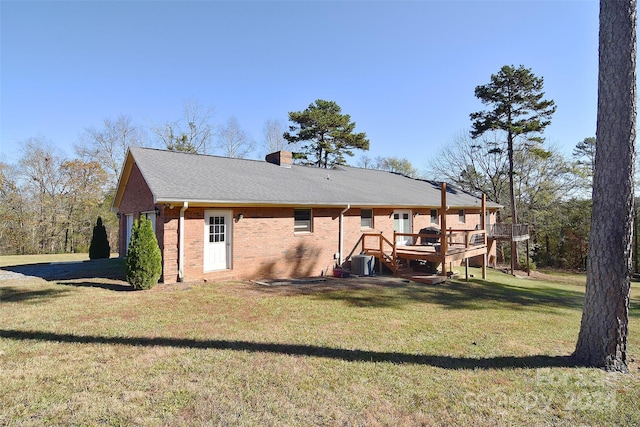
[{"xmin": 126, "ymin": 217, "xmax": 162, "ymax": 289}]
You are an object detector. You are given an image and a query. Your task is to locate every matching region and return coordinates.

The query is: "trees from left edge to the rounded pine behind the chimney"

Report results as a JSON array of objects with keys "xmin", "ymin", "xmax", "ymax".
[{"xmin": 0, "ymin": 100, "xmax": 383, "ymax": 255}]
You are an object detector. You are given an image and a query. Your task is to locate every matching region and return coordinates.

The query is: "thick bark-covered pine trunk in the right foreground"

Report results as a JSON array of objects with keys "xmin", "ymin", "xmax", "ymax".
[{"xmin": 574, "ymin": 0, "xmax": 636, "ymax": 371}]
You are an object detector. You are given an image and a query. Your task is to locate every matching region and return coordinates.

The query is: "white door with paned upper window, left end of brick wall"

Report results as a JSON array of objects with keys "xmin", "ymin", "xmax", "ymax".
[{"xmin": 204, "ymin": 210, "xmax": 231, "ymax": 271}]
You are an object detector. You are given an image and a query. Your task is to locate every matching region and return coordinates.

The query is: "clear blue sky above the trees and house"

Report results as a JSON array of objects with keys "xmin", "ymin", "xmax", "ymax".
[{"xmin": 0, "ymin": 0, "xmax": 598, "ymax": 169}]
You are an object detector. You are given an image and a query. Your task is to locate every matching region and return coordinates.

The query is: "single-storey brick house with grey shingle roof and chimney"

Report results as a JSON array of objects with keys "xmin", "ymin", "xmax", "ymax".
[{"xmin": 112, "ymin": 148, "xmax": 500, "ymax": 283}]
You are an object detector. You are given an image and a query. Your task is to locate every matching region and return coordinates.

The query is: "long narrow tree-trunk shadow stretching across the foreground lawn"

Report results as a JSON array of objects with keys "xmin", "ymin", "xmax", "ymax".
[{"xmin": 0, "ymin": 329, "xmax": 581, "ymax": 369}]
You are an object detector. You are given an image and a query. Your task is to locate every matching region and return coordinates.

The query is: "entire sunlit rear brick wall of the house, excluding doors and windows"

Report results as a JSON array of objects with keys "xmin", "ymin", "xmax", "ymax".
[{"xmin": 161, "ymin": 207, "xmax": 498, "ymax": 283}]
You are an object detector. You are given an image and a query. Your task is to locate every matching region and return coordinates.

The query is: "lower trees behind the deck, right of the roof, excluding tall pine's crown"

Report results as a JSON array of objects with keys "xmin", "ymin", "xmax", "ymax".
[{"xmin": 426, "ymin": 131, "xmax": 595, "ymax": 269}]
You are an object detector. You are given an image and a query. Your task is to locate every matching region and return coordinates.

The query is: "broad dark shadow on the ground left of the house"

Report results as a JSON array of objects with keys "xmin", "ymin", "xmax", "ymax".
[{"xmin": 1, "ymin": 258, "xmax": 125, "ymax": 281}]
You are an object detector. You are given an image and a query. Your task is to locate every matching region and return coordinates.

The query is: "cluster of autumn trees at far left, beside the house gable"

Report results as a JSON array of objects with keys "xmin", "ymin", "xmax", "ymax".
[{"xmin": 5, "ymin": 138, "xmax": 115, "ymax": 254}]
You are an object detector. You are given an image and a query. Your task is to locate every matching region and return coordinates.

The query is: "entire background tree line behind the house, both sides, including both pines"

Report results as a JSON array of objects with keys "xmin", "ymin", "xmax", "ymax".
[{"xmin": 0, "ymin": 66, "xmax": 632, "ymax": 269}]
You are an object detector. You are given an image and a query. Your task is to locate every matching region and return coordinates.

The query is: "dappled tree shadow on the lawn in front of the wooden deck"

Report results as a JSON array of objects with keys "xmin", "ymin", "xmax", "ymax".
[{"xmin": 315, "ymin": 280, "xmax": 584, "ymax": 310}]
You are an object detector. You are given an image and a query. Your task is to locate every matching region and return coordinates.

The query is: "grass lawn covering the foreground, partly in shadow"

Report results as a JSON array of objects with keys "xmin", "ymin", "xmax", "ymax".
[{"xmin": 0, "ymin": 257, "xmax": 640, "ymax": 426}]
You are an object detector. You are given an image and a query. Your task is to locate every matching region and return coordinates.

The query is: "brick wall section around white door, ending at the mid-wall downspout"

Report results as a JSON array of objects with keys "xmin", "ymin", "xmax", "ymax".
[{"xmin": 164, "ymin": 207, "xmax": 340, "ymax": 282}]
